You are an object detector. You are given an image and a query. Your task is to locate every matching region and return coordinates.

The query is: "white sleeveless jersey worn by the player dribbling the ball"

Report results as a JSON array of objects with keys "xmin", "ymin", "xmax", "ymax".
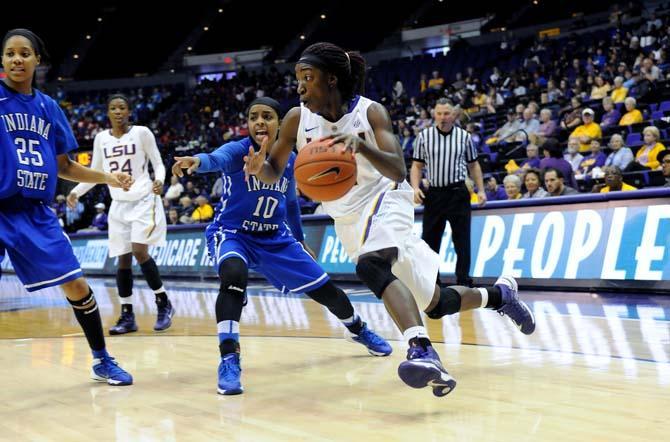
[{"xmin": 297, "ymin": 96, "xmax": 393, "ymax": 218}]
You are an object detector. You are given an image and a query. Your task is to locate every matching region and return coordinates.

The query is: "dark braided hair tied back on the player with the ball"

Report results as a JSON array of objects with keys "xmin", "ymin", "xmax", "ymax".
[{"xmin": 298, "ymin": 42, "xmax": 366, "ymax": 101}]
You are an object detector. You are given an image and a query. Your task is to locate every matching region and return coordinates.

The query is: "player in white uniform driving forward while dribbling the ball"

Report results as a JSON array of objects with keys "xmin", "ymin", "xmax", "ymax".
[{"xmin": 245, "ymin": 43, "xmax": 535, "ymax": 396}]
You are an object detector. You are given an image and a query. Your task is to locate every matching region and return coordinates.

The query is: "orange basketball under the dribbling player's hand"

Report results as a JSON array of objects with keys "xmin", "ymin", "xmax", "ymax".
[{"xmin": 295, "ymin": 140, "xmax": 356, "ymax": 201}]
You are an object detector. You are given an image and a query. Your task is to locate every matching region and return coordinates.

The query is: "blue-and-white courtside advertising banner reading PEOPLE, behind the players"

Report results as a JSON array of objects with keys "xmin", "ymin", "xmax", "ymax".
[{"xmin": 2, "ymin": 198, "xmax": 670, "ymax": 289}]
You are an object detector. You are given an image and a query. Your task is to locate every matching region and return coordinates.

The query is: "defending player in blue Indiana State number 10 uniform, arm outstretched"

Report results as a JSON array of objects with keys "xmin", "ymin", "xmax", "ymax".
[{"xmin": 172, "ymin": 97, "xmax": 392, "ymax": 395}]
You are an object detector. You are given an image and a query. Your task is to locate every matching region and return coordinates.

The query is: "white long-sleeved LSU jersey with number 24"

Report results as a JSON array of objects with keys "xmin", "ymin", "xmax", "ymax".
[{"xmin": 72, "ymin": 126, "xmax": 165, "ymax": 201}]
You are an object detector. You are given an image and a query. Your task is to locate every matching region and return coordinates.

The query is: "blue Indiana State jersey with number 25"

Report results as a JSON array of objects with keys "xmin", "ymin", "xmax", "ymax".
[{"xmin": 0, "ymin": 80, "xmax": 77, "ymax": 202}]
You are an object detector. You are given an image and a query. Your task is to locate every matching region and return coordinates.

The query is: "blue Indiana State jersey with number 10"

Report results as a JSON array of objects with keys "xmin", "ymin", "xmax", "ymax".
[{"xmin": 196, "ymin": 137, "xmax": 303, "ymax": 241}]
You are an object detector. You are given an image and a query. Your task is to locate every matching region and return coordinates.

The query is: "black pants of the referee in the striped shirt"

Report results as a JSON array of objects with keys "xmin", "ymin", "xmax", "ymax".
[{"xmin": 421, "ymin": 183, "xmax": 472, "ymax": 286}]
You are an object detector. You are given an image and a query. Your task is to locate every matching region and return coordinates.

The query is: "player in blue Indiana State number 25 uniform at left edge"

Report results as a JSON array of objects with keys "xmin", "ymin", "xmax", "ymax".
[{"xmin": 0, "ymin": 29, "xmax": 133, "ymax": 385}]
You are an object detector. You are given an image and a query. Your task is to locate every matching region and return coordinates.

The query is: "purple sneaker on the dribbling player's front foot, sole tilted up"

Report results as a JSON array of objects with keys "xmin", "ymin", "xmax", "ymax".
[{"xmin": 398, "ymin": 345, "xmax": 456, "ymax": 397}]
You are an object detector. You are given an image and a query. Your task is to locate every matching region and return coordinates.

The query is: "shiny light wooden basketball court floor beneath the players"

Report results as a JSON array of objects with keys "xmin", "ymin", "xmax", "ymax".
[{"xmin": 0, "ymin": 275, "xmax": 670, "ymax": 442}]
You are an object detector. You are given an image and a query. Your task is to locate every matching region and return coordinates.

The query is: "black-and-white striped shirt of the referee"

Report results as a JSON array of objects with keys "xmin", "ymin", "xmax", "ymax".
[{"xmin": 412, "ymin": 126, "xmax": 477, "ymax": 187}]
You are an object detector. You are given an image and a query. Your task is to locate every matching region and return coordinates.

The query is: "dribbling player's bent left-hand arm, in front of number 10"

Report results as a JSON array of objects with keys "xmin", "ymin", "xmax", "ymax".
[{"xmin": 244, "ymin": 107, "xmax": 300, "ymax": 184}]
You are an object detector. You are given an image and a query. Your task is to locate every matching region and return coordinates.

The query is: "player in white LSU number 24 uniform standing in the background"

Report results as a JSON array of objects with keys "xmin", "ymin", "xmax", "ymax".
[{"xmin": 68, "ymin": 94, "xmax": 172, "ymax": 334}]
